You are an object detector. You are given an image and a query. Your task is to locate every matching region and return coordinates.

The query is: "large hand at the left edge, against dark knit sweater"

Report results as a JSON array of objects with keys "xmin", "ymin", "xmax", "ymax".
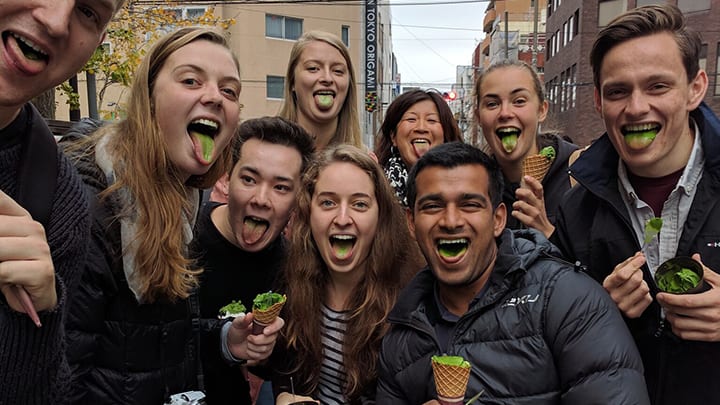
[{"xmin": 0, "ymin": 191, "xmax": 57, "ymax": 312}]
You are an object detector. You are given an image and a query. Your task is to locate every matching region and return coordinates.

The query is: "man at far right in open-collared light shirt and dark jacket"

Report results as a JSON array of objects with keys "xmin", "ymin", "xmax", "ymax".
[{"xmin": 551, "ymin": 5, "xmax": 720, "ymax": 404}]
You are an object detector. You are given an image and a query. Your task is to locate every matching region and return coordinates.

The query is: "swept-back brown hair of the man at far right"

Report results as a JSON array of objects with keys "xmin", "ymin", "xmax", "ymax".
[{"xmin": 590, "ymin": 4, "xmax": 702, "ymax": 89}]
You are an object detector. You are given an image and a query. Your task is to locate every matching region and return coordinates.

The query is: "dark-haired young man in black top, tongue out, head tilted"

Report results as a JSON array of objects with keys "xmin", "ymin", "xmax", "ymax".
[{"xmin": 192, "ymin": 117, "xmax": 314, "ymax": 404}]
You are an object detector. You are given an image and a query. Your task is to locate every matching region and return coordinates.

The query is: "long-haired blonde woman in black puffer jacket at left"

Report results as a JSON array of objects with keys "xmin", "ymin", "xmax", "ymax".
[{"xmin": 66, "ymin": 27, "xmax": 282, "ymax": 404}]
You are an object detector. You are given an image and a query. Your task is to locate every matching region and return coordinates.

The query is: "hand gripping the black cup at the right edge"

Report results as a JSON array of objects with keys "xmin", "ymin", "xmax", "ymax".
[{"xmin": 657, "ymin": 253, "xmax": 720, "ymax": 342}]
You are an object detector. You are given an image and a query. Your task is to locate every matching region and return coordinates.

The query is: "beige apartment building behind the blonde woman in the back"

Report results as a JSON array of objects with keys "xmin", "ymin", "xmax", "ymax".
[{"xmin": 57, "ymin": 0, "xmax": 397, "ymax": 145}]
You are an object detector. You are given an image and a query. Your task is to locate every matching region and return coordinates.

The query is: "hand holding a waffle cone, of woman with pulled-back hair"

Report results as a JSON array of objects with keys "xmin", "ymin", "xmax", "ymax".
[{"xmin": 510, "ymin": 176, "xmax": 555, "ymax": 238}]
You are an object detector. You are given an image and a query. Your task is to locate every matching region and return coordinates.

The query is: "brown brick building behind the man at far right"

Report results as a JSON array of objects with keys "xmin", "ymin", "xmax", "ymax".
[{"xmin": 545, "ymin": 0, "xmax": 720, "ymax": 146}]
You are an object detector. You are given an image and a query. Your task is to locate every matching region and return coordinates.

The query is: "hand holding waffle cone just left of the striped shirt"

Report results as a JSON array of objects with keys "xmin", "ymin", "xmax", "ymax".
[{"xmin": 227, "ymin": 312, "xmax": 285, "ymax": 366}]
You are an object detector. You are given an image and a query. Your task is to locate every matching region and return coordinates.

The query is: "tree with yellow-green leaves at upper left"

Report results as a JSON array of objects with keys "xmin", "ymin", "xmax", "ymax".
[{"xmin": 60, "ymin": 0, "xmax": 235, "ymax": 118}]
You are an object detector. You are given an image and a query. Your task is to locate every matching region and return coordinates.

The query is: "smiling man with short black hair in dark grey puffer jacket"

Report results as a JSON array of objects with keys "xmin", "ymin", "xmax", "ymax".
[{"xmin": 377, "ymin": 143, "xmax": 649, "ymax": 404}]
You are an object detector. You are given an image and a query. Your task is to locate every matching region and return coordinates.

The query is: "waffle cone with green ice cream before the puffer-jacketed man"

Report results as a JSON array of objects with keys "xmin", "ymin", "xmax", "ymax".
[{"xmin": 431, "ymin": 356, "xmax": 472, "ymax": 405}]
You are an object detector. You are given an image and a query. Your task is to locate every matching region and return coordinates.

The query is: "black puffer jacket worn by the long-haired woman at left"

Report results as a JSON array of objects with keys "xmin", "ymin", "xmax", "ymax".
[{"xmin": 60, "ymin": 125, "xmax": 197, "ymax": 405}]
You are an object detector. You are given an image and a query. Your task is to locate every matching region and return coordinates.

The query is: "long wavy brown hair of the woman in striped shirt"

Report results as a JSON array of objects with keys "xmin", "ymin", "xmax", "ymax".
[{"xmin": 283, "ymin": 145, "xmax": 417, "ymax": 400}]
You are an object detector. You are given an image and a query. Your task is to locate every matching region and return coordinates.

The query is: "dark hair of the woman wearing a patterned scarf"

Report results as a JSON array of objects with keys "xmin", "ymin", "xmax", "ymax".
[{"xmin": 375, "ymin": 90, "xmax": 463, "ymax": 166}]
